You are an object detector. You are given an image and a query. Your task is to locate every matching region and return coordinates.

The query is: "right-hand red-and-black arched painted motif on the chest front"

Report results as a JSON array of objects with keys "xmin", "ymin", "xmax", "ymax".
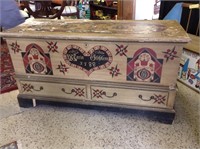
[{"xmin": 127, "ymin": 47, "xmax": 163, "ymax": 83}]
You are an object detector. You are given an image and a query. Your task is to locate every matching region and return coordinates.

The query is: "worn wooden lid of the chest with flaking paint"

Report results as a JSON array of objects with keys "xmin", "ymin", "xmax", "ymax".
[{"xmin": 0, "ymin": 19, "xmax": 190, "ymax": 42}]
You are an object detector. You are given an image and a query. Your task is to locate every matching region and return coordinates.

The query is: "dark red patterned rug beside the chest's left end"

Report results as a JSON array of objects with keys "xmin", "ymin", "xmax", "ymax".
[{"xmin": 0, "ymin": 40, "xmax": 17, "ymax": 94}]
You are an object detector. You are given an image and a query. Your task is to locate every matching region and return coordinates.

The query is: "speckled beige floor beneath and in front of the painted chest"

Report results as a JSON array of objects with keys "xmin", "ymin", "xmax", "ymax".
[{"xmin": 0, "ymin": 82, "xmax": 200, "ymax": 149}]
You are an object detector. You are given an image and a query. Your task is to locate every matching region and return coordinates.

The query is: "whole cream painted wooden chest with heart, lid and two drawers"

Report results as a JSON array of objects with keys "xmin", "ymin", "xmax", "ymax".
[{"xmin": 1, "ymin": 20, "xmax": 190, "ymax": 123}]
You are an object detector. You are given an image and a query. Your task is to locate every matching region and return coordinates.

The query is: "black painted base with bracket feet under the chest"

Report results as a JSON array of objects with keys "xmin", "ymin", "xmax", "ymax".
[{"xmin": 18, "ymin": 96, "xmax": 175, "ymax": 124}]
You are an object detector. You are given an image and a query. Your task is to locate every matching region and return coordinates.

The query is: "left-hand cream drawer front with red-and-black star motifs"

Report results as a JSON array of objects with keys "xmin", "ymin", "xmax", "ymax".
[{"xmin": 19, "ymin": 81, "xmax": 87, "ymax": 99}]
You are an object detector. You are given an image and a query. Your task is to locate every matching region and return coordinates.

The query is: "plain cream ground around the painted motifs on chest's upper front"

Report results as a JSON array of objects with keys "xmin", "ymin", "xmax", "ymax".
[{"xmin": 7, "ymin": 39, "xmax": 182, "ymax": 86}]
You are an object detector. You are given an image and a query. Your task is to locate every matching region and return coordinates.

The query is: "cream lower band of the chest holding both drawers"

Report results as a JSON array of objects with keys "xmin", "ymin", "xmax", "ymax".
[{"xmin": 19, "ymin": 81, "xmax": 170, "ymax": 109}]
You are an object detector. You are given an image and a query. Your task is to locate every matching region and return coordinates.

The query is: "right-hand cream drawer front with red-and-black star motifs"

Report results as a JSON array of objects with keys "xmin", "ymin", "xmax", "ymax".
[{"xmin": 90, "ymin": 86, "xmax": 169, "ymax": 108}]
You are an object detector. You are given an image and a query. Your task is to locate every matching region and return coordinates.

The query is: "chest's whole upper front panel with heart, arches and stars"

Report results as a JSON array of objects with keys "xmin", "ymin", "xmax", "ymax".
[{"xmin": 7, "ymin": 38, "xmax": 181, "ymax": 86}]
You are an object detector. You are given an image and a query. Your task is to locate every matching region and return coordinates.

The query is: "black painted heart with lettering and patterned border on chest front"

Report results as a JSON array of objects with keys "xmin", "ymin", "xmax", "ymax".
[{"xmin": 63, "ymin": 45, "xmax": 113, "ymax": 76}]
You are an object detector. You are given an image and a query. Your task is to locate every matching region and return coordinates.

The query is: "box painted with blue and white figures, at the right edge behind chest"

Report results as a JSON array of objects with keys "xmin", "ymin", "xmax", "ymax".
[{"xmin": 178, "ymin": 34, "xmax": 200, "ymax": 93}]
